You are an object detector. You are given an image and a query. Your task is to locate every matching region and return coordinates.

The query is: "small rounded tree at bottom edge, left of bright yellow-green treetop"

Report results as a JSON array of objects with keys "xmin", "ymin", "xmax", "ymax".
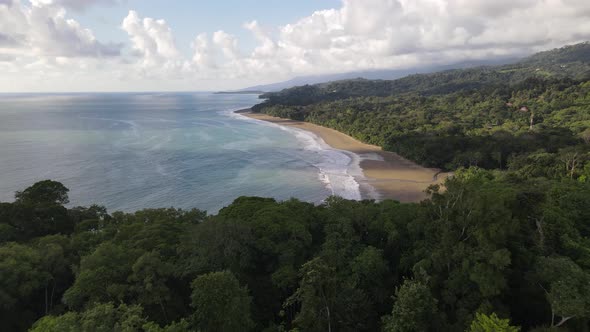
[{"xmin": 383, "ymin": 279, "xmax": 437, "ymax": 332}]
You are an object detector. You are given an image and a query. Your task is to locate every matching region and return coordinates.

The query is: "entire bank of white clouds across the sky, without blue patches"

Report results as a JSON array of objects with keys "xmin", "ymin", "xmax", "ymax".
[{"xmin": 0, "ymin": 0, "xmax": 590, "ymax": 89}]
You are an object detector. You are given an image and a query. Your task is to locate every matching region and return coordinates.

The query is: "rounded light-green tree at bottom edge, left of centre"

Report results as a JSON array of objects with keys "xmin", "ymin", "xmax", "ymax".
[{"xmin": 191, "ymin": 271, "xmax": 254, "ymax": 332}]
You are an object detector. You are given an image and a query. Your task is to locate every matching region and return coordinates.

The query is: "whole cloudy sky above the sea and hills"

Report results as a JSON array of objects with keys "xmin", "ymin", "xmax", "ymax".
[{"xmin": 0, "ymin": 0, "xmax": 590, "ymax": 92}]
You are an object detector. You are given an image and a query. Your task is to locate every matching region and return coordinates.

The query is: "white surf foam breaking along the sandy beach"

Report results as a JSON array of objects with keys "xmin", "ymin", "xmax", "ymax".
[{"xmin": 229, "ymin": 111, "xmax": 378, "ymax": 200}]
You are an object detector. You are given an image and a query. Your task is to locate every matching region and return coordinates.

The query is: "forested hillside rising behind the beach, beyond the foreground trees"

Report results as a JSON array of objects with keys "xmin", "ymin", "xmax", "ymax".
[{"xmin": 253, "ymin": 43, "xmax": 590, "ymax": 170}]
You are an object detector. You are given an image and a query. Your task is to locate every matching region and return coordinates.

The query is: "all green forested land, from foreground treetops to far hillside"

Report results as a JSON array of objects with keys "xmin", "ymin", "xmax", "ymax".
[{"xmin": 0, "ymin": 44, "xmax": 590, "ymax": 332}]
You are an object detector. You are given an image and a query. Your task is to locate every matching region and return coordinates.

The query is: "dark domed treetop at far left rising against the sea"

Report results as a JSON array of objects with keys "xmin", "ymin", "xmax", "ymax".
[{"xmin": 14, "ymin": 180, "xmax": 70, "ymax": 205}]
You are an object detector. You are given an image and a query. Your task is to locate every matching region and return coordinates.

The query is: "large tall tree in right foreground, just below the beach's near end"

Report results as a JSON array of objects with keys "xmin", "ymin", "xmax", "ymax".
[{"xmin": 414, "ymin": 168, "xmax": 520, "ymax": 329}]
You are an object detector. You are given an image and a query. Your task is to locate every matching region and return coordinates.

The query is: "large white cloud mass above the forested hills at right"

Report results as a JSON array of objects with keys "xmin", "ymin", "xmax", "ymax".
[{"xmin": 236, "ymin": 0, "xmax": 590, "ymax": 74}]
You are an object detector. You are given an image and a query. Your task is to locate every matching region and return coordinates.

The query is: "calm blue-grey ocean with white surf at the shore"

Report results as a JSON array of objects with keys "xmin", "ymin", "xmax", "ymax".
[{"xmin": 0, "ymin": 93, "xmax": 361, "ymax": 213}]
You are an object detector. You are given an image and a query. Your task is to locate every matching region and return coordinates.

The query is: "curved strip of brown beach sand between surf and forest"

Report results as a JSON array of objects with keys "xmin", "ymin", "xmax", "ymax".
[{"xmin": 240, "ymin": 112, "xmax": 448, "ymax": 202}]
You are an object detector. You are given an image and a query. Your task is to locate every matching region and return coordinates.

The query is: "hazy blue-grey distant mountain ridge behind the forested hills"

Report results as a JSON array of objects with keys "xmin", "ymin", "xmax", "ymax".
[{"xmin": 238, "ymin": 58, "xmax": 519, "ymax": 92}]
